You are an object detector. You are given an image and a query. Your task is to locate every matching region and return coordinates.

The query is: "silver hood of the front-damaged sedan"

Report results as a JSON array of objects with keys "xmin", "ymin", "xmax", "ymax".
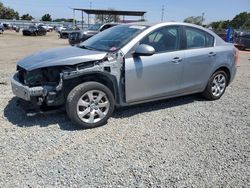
[{"xmin": 17, "ymin": 47, "xmax": 107, "ymax": 71}]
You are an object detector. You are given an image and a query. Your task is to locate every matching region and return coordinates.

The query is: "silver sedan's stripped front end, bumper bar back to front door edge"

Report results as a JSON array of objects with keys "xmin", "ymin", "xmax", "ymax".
[{"xmin": 11, "ymin": 50, "xmax": 122, "ymax": 115}]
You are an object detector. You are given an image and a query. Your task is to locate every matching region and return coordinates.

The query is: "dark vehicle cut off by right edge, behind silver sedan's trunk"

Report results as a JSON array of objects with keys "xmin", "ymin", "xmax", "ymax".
[{"xmin": 234, "ymin": 31, "xmax": 250, "ymax": 50}]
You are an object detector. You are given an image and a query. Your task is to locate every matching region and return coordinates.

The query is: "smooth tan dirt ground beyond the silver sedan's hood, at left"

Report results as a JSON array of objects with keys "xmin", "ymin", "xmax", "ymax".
[{"xmin": 0, "ymin": 31, "xmax": 68, "ymax": 73}]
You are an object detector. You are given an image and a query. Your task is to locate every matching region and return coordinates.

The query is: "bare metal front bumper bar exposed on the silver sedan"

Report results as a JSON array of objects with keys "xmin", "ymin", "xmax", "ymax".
[{"xmin": 11, "ymin": 74, "xmax": 46, "ymax": 101}]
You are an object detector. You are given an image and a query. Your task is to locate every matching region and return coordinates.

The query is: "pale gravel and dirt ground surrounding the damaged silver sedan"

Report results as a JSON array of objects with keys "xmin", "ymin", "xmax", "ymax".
[{"xmin": 0, "ymin": 32, "xmax": 250, "ymax": 187}]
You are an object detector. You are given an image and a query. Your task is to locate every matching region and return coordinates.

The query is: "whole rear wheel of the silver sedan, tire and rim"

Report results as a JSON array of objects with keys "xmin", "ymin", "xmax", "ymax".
[{"xmin": 202, "ymin": 71, "xmax": 228, "ymax": 100}]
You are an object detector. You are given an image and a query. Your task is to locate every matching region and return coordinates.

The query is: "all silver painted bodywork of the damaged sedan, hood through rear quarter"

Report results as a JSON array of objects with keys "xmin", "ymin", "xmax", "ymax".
[{"xmin": 13, "ymin": 22, "xmax": 236, "ymax": 106}]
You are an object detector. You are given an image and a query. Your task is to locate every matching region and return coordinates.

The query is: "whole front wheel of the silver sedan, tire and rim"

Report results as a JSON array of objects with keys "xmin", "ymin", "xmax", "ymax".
[{"xmin": 66, "ymin": 82, "xmax": 115, "ymax": 128}]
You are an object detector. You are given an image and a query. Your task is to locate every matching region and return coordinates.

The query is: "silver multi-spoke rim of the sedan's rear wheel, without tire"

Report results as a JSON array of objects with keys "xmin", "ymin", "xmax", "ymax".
[{"xmin": 212, "ymin": 74, "xmax": 226, "ymax": 97}]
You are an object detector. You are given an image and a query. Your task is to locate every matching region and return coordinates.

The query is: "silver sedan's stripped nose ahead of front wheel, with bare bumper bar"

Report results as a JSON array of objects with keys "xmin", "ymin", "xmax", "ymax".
[{"xmin": 11, "ymin": 66, "xmax": 64, "ymax": 115}]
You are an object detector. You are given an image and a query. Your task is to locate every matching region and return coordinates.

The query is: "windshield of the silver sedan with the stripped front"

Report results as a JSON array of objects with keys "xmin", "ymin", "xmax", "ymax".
[{"xmin": 79, "ymin": 25, "xmax": 147, "ymax": 52}]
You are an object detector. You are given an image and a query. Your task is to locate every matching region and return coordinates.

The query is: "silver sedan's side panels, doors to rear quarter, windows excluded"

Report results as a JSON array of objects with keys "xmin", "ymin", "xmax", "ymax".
[{"xmin": 122, "ymin": 22, "xmax": 236, "ymax": 104}]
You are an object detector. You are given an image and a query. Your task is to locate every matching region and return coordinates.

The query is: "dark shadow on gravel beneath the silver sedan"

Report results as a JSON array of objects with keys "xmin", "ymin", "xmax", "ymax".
[{"xmin": 4, "ymin": 94, "xmax": 204, "ymax": 131}]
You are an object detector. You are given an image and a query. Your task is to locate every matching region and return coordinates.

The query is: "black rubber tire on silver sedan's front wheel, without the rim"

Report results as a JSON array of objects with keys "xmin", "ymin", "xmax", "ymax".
[{"xmin": 66, "ymin": 82, "xmax": 115, "ymax": 129}]
